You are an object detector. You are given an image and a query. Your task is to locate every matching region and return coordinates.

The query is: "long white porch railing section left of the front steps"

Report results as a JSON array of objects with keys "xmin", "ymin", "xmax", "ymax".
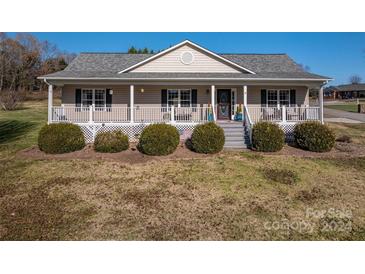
[{"xmin": 51, "ymin": 106, "xmax": 213, "ymax": 123}]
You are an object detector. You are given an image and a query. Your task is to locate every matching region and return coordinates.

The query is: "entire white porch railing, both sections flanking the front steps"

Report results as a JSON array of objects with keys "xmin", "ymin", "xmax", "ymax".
[{"xmin": 51, "ymin": 106, "xmax": 320, "ymax": 123}]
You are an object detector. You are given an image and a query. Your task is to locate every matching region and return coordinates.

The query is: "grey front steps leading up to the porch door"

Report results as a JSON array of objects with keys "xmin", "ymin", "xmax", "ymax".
[{"xmin": 217, "ymin": 121, "xmax": 247, "ymax": 149}]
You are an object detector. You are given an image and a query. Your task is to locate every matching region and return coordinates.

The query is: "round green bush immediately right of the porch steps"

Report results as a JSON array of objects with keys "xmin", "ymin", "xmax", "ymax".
[{"xmin": 252, "ymin": 122, "xmax": 285, "ymax": 152}]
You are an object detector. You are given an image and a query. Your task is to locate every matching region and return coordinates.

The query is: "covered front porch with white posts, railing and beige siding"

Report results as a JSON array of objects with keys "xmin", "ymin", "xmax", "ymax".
[{"xmin": 48, "ymin": 85, "xmax": 323, "ymax": 125}]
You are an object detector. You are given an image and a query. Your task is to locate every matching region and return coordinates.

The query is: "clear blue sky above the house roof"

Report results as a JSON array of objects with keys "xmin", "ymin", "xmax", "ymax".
[{"xmin": 9, "ymin": 33, "xmax": 365, "ymax": 84}]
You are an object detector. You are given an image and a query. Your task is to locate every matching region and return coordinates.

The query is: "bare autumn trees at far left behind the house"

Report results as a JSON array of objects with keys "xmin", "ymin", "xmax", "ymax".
[{"xmin": 0, "ymin": 32, "xmax": 76, "ymax": 110}]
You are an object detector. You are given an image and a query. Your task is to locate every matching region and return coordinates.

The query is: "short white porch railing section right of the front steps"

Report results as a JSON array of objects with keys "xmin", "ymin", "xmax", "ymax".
[{"xmin": 247, "ymin": 106, "xmax": 320, "ymax": 123}]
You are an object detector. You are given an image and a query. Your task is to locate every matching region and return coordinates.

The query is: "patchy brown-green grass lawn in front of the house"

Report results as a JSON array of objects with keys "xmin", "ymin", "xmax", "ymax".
[{"xmin": 0, "ymin": 102, "xmax": 365, "ymax": 240}]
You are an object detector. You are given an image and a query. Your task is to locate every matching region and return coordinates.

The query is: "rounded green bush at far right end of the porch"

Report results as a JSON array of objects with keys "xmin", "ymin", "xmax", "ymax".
[{"xmin": 294, "ymin": 121, "xmax": 336, "ymax": 152}]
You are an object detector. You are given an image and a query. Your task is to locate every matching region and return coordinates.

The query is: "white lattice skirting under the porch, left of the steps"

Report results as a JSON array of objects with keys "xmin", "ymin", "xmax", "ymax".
[{"xmin": 79, "ymin": 123, "xmax": 196, "ymax": 143}]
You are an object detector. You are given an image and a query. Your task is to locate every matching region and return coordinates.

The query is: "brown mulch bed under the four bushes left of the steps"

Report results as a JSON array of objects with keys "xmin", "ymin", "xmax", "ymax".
[{"xmin": 18, "ymin": 144, "xmax": 212, "ymax": 164}]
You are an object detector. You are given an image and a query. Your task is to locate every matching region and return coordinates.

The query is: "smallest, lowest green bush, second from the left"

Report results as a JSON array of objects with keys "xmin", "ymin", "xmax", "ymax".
[{"xmin": 94, "ymin": 130, "xmax": 129, "ymax": 153}]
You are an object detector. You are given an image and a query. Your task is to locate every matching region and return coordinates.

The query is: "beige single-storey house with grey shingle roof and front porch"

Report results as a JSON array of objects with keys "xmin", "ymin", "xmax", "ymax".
[{"xmin": 39, "ymin": 40, "xmax": 331, "ymax": 146}]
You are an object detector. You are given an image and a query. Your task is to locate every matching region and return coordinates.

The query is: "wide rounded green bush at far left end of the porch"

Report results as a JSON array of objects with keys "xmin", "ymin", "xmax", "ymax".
[{"xmin": 38, "ymin": 123, "xmax": 85, "ymax": 154}]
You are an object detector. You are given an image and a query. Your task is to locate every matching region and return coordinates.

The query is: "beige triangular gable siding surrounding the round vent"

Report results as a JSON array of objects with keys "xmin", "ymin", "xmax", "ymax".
[{"xmin": 131, "ymin": 45, "xmax": 241, "ymax": 73}]
